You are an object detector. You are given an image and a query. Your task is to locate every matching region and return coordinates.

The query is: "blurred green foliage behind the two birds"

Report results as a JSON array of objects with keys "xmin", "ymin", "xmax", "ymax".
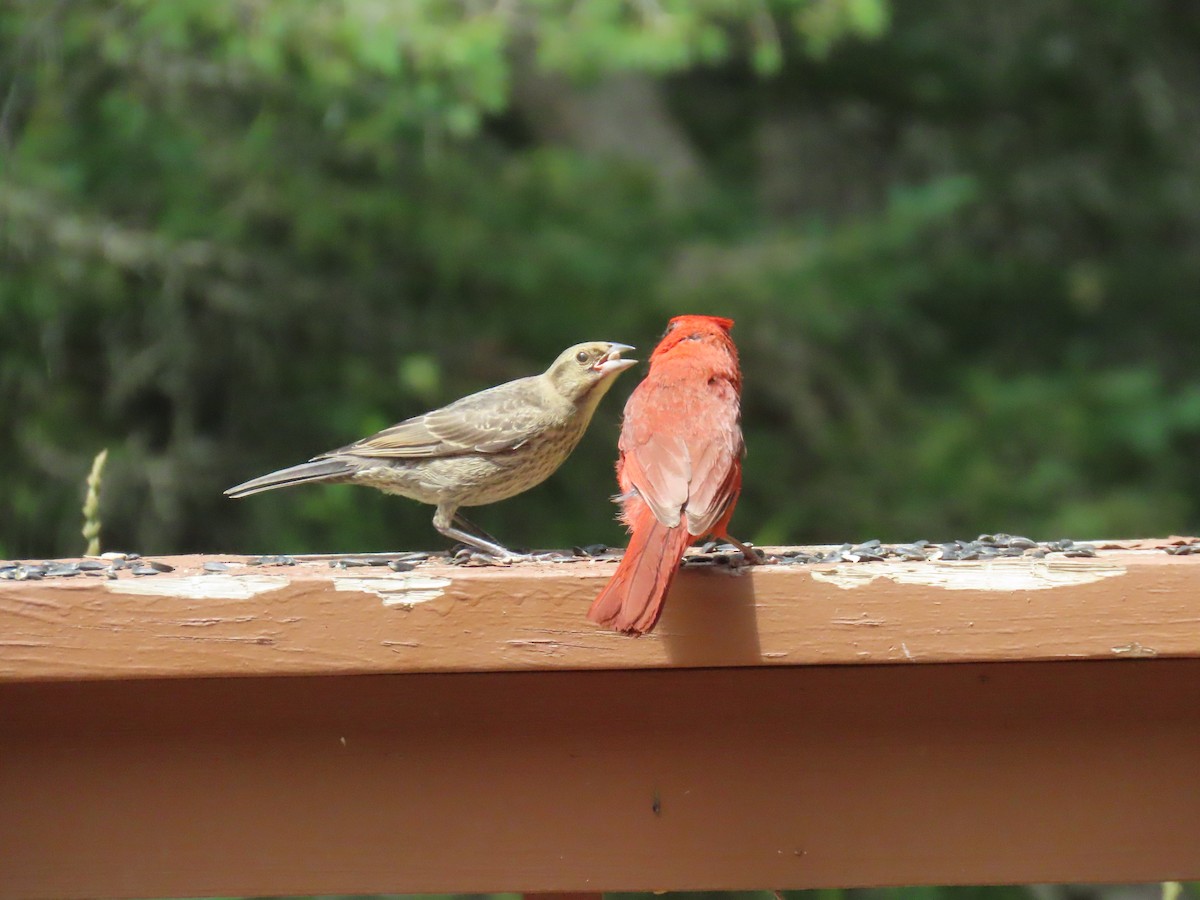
[{"xmin": 0, "ymin": 0, "xmax": 1200, "ymax": 558}]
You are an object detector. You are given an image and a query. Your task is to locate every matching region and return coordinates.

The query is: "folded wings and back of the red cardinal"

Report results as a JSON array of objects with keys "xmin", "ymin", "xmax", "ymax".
[{"xmin": 619, "ymin": 379, "xmax": 744, "ymax": 535}]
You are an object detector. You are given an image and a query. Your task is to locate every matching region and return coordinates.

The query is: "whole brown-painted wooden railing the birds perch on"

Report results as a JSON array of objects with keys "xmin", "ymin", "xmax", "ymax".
[{"xmin": 0, "ymin": 541, "xmax": 1200, "ymax": 900}]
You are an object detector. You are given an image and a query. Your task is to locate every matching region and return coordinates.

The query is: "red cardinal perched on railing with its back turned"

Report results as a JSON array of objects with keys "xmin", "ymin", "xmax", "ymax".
[{"xmin": 588, "ymin": 316, "xmax": 757, "ymax": 635}]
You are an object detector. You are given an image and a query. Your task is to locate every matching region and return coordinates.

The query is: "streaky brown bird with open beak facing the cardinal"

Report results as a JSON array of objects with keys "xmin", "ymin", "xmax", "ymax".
[{"xmin": 226, "ymin": 341, "xmax": 637, "ymax": 559}]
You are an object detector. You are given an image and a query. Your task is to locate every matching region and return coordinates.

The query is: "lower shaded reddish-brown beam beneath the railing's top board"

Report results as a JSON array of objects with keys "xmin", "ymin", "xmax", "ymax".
[{"xmin": 0, "ymin": 660, "xmax": 1200, "ymax": 900}]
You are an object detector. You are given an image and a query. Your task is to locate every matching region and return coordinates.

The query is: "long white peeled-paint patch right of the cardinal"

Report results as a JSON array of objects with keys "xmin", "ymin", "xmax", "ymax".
[{"xmin": 811, "ymin": 559, "xmax": 1126, "ymax": 592}]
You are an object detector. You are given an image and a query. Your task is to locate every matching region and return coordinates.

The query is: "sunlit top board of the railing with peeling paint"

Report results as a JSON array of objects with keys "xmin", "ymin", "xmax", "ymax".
[{"xmin": 0, "ymin": 548, "xmax": 1200, "ymax": 680}]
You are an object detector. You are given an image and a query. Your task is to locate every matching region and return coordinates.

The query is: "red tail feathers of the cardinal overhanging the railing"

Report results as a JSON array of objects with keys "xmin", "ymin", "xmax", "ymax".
[{"xmin": 588, "ymin": 506, "xmax": 694, "ymax": 635}]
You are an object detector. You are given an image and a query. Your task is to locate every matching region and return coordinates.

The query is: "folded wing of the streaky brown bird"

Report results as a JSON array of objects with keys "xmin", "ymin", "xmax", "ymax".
[{"xmin": 317, "ymin": 377, "xmax": 551, "ymax": 458}]
